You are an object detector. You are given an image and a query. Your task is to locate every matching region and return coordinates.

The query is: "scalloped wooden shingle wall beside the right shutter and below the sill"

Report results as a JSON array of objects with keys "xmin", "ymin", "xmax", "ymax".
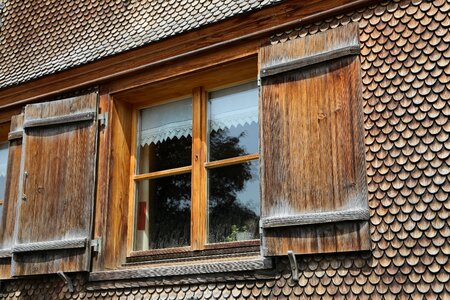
[{"xmin": 2, "ymin": 0, "xmax": 450, "ymax": 299}]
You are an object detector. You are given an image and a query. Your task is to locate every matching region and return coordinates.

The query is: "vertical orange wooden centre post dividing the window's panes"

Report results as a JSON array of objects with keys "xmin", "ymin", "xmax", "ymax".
[{"xmin": 191, "ymin": 87, "xmax": 207, "ymax": 250}]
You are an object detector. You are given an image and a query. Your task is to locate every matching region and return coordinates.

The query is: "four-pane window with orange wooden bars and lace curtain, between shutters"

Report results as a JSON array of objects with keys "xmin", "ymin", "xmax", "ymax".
[{"xmin": 133, "ymin": 81, "xmax": 260, "ymax": 251}]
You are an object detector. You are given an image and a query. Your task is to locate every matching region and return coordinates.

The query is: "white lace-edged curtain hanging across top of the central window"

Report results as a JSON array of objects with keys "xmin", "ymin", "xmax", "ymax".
[{"xmin": 140, "ymin": 82, "xmax": 258, "ymax": 146}]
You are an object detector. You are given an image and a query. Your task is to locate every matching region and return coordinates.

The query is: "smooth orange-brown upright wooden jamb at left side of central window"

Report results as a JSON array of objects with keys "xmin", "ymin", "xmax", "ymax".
[{"xmin": 96, "ymin": 98, "xmax": 133, "ymax": 270}]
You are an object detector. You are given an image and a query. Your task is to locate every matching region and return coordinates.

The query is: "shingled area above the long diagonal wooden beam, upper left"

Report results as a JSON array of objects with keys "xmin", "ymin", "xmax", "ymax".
[{"xmin": 0, "ymin": 0, "xmax": 281, "ymax": 88}]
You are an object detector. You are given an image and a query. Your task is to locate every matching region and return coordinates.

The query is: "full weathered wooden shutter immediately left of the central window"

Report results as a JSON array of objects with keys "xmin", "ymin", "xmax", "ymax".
[{"xmin": 12, "ymin": 93, "xmax": 98, "ymax": 276}]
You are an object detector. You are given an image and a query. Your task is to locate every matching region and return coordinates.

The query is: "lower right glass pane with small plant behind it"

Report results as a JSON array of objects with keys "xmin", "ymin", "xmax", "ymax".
[{"xmin": 208, "ymin": 160, "xmax": 260, "ymax": 243}]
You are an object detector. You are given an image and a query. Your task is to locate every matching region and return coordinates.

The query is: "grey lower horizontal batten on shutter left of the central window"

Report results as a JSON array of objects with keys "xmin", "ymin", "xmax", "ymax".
[{"xmin": 12, "ymin": 238, "xmax": 87, "ymax": 253}]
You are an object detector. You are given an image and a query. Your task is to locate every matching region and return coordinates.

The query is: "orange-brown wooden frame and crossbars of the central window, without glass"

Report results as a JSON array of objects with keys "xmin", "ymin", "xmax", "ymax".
[{"xmin": 127, "ymin": 70, "xmax": 260, "ymax": 258}]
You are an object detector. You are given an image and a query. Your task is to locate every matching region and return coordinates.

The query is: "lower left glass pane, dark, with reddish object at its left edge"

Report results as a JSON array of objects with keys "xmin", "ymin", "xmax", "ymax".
[{"xmin": 135, "ymin": 174, "xmax": 191, "ymax": 250}]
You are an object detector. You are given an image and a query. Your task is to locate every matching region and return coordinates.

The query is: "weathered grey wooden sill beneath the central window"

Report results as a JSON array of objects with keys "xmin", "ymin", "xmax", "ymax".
[{"xmin": 89, "ymin": 256, "xmax": 272, "ymax": 282}]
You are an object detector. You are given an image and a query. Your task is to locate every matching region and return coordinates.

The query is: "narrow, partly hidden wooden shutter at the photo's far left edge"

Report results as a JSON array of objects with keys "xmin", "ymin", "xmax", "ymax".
[{"xmin": 0, "ymin": 114, "xmax": 23, "ymax": 279}]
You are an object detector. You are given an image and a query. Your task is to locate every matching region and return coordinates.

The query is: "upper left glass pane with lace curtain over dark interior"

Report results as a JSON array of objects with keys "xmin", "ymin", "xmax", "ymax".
[{"xmin": 138, "ymin": 98, "xmax": 192, "ymax": 174}]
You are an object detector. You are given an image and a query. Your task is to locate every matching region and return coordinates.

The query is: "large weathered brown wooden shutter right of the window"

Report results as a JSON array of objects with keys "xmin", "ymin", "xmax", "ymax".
[{"xmin": 260, "ymin": 24, "xmax": 370, "ymax": 255}]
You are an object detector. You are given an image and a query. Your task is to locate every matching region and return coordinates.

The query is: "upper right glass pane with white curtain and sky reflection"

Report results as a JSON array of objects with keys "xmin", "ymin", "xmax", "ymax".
[{"xmin": 208, "ymin": 82, "xmax": 259, "ymax": 161}]
